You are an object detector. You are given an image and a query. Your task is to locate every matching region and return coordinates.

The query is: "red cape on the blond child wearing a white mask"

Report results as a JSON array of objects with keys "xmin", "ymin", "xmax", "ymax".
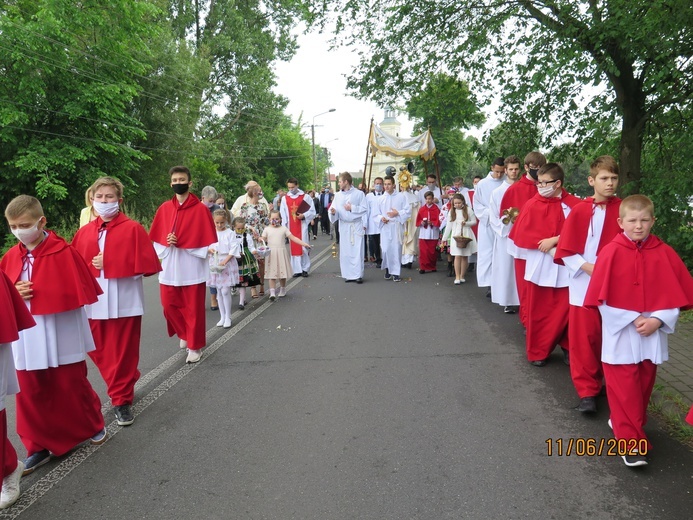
[{"xmin": 72, "ymin": 212, "xmax": 161, "ymax": 278}]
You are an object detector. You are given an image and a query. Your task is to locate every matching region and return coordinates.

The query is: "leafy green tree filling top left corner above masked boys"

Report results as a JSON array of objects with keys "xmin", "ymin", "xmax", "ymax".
[{"xmin": 0, "ymin": 0, "xmax": 164, "ymax": 217}]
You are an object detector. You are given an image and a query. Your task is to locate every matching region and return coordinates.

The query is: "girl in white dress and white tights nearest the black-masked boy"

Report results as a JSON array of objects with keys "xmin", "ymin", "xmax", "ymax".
[{"xmin": 207, "ymin": 209, "xmax": 241, "ymax": 329}]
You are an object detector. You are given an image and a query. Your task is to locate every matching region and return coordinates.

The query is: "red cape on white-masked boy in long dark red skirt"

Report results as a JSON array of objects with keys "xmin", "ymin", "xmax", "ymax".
[{"xmin": 0, "ymin": 231, "xmax": 103, "ymax": 315}]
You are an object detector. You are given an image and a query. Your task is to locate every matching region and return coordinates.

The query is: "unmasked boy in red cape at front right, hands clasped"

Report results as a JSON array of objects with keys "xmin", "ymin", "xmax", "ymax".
[{"xmin": 585, "ymin": 195, "xmax": 693, "ymax": 467}]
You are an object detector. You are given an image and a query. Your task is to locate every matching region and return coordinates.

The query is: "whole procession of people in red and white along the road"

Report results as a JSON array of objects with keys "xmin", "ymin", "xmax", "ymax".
[{"xmin": 0, "ymin": 156, "xmax": 693, "ymax": 508}]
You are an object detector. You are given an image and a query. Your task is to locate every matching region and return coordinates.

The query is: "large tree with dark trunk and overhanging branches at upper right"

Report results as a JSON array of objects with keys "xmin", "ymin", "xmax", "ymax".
[{"xmin": 316, "ymin": 0, "xmax": 693, "ymax": 190}]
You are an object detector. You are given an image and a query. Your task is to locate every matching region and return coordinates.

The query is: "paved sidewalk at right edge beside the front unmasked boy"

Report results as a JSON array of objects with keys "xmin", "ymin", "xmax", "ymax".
[{"xmin": 657, "ymin": 322, "xmax": 693, "ymax": 412}]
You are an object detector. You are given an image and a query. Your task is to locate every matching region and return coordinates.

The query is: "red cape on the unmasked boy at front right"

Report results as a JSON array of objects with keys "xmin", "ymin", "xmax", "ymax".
[{"xmin": 585, "ymin": 233, "xmax": 693, "ymax": 312}]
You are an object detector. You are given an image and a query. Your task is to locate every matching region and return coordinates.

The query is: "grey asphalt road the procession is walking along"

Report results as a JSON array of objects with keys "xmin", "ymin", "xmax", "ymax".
[{"xmin": 0, "ymin": 237, "xmax": 693, "ymax": 520}]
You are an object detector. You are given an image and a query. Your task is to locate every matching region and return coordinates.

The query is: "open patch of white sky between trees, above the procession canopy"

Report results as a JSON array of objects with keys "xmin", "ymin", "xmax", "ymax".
[{"xmin": 275, "ymin": 29, "xmax": 413, "ymax": 173}]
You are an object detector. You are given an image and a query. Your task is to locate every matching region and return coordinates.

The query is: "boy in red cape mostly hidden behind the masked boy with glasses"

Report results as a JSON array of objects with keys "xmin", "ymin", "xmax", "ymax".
[{"xmin": 500, "ymin": 152, "xmax": 546, "ymax": 327}]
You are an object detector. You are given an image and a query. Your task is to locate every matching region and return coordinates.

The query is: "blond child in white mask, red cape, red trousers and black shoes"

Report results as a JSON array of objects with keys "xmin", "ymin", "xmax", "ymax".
[{"xmin": 72, "ymin": 177, "xmax": 161, "ymax": 426}]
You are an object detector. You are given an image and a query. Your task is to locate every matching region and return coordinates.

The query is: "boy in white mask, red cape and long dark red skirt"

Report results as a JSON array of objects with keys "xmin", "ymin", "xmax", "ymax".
[{"xmin": 0, "ymin": 195, "xmax": 107, "ymax": 475}]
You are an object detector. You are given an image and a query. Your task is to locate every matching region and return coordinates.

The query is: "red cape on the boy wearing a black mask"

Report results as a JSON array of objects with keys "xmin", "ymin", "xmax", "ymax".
[{"xmin": 149, "ymin": 193, "xmax": 217, "ymax": 249}]
